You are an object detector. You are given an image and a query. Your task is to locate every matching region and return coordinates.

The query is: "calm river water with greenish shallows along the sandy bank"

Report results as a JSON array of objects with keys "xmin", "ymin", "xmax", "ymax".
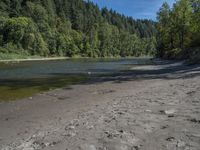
[{"xmin": 0, "ymin": 58, "xmax": 151, "ymax": 101}]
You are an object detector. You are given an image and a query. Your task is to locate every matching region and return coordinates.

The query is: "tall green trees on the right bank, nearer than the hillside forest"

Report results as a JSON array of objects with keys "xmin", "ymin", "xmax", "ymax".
[{"xmin": 156, "ymin": 0, "xmax": 200, "ymax": 62}]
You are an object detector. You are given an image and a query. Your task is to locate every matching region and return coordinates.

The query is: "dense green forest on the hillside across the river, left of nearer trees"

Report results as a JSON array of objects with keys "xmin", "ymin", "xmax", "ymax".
[{"xmin": 0, "ymin": 0, "xmax": 157, "ymax": 57}]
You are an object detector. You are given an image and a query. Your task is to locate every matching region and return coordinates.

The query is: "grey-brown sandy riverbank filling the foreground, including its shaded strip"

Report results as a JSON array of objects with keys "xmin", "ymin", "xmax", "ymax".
[{"xmin": 0, "ymin": 63, "xmax": 200, "ymax": 150}]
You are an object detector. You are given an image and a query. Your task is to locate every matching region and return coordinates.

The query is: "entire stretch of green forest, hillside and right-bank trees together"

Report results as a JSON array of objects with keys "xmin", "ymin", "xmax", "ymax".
[{"xmin": 0, "ymin": 0, "xmax": 200, "ymax": 60}]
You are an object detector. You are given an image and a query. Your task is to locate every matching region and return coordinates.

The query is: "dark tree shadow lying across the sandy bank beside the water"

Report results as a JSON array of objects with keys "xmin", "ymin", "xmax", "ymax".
[{"xmin": 85, "ymin": 62, "xmax": 200, "ymax": 84}]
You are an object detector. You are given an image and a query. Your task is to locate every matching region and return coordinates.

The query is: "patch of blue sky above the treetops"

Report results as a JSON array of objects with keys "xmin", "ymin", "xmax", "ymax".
[{"xmin": 86, "ymin": 0, "xmax": 175, "ymax": 20}]
